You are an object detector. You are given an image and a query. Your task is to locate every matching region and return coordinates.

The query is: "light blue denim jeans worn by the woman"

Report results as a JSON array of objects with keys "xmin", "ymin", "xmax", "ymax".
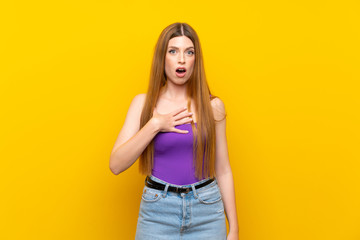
[{"xmin": 135, "ymin": 175, "xmax": 227, "ymax": 240}]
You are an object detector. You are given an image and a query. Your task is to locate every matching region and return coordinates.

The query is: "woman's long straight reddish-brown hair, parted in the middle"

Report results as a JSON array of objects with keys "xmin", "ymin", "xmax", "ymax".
[{"xmin": 139, "ymin": 22, "xmax": 221, "ymax": 179}]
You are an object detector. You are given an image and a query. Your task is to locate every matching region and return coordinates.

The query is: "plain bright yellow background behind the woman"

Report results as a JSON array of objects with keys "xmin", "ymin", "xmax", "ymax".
[{"xmin": 0, "ymin": 0, "xmax": 360, "ymax": 240}]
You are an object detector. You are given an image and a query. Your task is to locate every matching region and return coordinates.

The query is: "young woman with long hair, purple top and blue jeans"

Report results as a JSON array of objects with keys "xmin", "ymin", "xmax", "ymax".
[{"xmin": 110, "ymin": 23, "xmax": 238, "ymax": 240}]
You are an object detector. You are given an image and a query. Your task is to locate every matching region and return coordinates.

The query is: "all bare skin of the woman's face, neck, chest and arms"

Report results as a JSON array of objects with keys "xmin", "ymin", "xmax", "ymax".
[{"xmin": 109, "ymin": 36, "xmax": 239, "ymax": 240}]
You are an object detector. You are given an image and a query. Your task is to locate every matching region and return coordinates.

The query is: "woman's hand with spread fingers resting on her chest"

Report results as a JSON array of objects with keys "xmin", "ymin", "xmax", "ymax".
[{"xmin": 151, "ymin": 107, "xmax": 193, "ymax": 133}]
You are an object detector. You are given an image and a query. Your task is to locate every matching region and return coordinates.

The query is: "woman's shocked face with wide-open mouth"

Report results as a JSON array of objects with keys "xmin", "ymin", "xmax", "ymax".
[{"xmin": 165, "ymin": 36, "xmax": 195, "ymax": 85}]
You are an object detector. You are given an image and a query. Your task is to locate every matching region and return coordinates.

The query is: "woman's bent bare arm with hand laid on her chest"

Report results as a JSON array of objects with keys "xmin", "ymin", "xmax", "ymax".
[{"xmin": 109, "ymin": 94, "xmax": 192, "ymax": 175}]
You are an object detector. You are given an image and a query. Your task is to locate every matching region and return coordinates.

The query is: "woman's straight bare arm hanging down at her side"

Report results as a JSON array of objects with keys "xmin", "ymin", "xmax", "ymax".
[{"xmin": 211, "ymin": 98, "xmax": 239, "ymax": 239}]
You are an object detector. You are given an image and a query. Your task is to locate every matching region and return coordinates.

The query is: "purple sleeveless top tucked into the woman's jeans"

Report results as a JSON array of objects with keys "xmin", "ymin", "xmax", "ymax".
[{"xmin": 152, "ymin": 123, "xmax": 202, "ymax": 185}]
